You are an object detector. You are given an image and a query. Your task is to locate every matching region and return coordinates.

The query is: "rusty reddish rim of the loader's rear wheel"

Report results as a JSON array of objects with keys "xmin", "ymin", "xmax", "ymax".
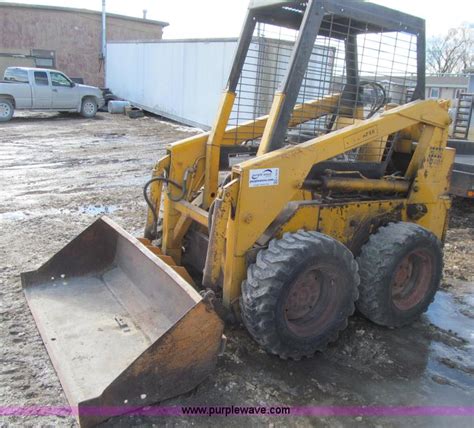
[{"xmin": 390, "ymin": 249, "xmax": 433, "ymax": 311}]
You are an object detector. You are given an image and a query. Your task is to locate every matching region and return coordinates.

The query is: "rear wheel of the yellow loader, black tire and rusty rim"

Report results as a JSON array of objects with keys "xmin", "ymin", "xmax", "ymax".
[{"xmin": 356, "ymin": 222, "xmax": 443, "ymax": 327}]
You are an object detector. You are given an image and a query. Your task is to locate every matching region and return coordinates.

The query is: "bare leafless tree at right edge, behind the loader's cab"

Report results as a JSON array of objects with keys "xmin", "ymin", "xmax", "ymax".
[{"xmin": 426, "ymin": 24, "xmax": 474, "ymax": 74}]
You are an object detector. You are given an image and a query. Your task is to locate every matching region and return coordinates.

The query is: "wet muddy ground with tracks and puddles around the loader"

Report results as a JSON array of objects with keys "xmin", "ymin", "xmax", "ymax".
[{"xmin": 0, "ymin": 113, "xmax": 474, "ymax": 427}]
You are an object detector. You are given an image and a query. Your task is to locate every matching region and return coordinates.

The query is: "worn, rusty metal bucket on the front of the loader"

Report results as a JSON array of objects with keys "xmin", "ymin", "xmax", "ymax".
[{"xmin": 22, "ymin": 217, "xmax": 227, "ymax": 426}]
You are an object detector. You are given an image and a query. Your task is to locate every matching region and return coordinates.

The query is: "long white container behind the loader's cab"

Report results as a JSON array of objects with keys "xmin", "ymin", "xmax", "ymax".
[{"xmin": 106, "ymin": 37, "xmax": 334, "ymax": 130}]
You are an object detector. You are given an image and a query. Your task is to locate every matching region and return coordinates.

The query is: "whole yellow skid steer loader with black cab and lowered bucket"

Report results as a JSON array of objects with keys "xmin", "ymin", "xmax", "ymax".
[{"xmin": 22, "ymin": 0, "xmax": 454, "ymax": 425}]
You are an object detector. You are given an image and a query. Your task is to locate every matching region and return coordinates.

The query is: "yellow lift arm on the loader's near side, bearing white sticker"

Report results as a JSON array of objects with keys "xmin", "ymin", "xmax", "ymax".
[{"xmin": 233, "ymin": 101, "xmax": 447, "ymax": 255}]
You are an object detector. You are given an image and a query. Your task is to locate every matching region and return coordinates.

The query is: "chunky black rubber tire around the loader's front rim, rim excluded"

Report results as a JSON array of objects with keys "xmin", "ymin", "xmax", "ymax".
[{"xmin": 240, "ymin": 231, "xmax": 359, "ymax": 360}]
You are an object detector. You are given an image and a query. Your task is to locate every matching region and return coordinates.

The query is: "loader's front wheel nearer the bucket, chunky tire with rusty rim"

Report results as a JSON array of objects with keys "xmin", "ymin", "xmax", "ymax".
[{"xmin": 240, "ymin": 231, "xmax": 359, "ymax": 360}]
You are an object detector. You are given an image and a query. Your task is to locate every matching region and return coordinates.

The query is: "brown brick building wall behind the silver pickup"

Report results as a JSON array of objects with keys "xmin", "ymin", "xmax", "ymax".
[{"xmin": 0, "ymin": 3, "xmax": 163, "ymax": 86}]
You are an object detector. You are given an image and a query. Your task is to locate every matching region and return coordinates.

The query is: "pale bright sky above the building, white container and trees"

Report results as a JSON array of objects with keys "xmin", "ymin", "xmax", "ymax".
[{"xmin": 0, "ymin": 0, "xmax": 474, "ymax": 38}]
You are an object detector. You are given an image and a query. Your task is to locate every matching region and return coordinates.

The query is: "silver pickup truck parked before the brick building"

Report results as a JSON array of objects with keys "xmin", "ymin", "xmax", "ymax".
[{"xmin": 0, "ymin": 67, "xmax": 104, "ymax": 122}]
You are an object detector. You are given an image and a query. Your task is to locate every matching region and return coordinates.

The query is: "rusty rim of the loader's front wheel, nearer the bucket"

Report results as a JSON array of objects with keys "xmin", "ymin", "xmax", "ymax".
[{"xmin": 283, "ymin": 266, "xmax": 342, "ymax": 337}]
